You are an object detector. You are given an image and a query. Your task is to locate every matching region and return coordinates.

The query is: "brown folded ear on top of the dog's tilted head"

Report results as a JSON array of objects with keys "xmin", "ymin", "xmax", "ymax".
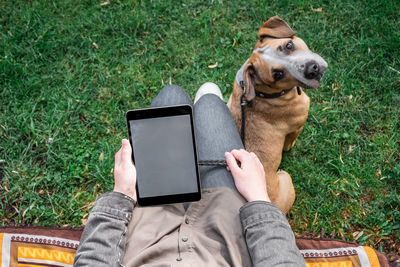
[{"xmin": 258, "ymin": 16, "xmax": 296, "ymax": 40}]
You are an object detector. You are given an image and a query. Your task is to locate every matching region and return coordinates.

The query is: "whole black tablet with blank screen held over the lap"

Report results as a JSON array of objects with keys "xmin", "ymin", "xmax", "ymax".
[{"xmin": 126, "ymin": 105, "xmax": 201, "ymax": 206}]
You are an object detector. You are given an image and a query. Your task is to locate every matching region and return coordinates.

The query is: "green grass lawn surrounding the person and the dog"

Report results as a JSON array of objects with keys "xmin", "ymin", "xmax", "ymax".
[{"xmin": 0, "ymin": 0, "xmax": 400, "ymax": 253}]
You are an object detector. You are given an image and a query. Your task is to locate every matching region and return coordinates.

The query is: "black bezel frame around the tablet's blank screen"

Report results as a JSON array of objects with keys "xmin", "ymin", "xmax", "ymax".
[{"xmin": 126, "ymin": 105, "xmax": 201, "ymax": 206}]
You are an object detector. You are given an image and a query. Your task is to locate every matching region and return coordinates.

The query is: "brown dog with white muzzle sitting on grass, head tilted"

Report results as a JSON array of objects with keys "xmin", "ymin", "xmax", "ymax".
[{"xmin": 228, "ymin": 16, "xmax": 328, "ymax": 213}]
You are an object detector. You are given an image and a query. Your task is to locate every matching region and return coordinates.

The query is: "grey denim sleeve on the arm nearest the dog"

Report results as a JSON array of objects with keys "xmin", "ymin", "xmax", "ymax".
[{"xmin": 240, "ymin": 201, "xmax": 305, "ymax": 266}]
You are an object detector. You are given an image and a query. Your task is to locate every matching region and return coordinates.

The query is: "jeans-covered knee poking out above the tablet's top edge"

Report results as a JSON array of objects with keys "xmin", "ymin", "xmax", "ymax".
[{"xmin": 151, "ymin": 84, "xmax": 193, "ymax": 107}]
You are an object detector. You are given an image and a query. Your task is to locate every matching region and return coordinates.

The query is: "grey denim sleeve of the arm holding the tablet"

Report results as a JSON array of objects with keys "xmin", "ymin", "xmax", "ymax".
[{"xmin": 74, "ymin": 192, "xmax": 135, "ymax": 267}]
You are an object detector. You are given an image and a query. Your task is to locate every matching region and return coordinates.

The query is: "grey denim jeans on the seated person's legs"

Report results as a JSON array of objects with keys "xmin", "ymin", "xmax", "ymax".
[{"xmin": 151, "ymin": 85, "xmax": 243, "ymax": 194}]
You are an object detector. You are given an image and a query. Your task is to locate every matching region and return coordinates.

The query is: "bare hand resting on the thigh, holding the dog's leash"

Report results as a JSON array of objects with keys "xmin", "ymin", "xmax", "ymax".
[{"xmin": 225, "ymin": 149, "xmax": 271, "ymax": 202}]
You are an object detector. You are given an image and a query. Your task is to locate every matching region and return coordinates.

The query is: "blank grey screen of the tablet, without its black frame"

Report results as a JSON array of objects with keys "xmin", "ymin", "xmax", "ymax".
[{"xmin": 129, "ymin": 115, "xmax": 198, "ymax": 198}]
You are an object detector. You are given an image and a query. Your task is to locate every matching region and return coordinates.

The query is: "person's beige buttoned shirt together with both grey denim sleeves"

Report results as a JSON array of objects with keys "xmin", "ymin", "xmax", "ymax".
[{"xmin": 74, "ymin": 189, "xmax": 305, "ymax": 267}]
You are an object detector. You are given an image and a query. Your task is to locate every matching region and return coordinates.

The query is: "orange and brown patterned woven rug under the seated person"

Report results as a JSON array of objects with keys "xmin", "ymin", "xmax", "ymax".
[{"xmin": 0, "ymin": 227, "xmax": 400, "ymax": 267}]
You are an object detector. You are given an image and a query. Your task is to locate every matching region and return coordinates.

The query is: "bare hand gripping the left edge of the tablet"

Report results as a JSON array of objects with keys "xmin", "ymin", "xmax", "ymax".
[{"xmin": 114, "ymin": 139, "xmax": 136, "ymax": 201}]
